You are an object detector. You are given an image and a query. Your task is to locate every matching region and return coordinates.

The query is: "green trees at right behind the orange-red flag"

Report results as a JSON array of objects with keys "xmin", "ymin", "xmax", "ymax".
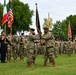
[{"xmin": 53, "ymin": 15, "xmax": 76, "ymax": 40}]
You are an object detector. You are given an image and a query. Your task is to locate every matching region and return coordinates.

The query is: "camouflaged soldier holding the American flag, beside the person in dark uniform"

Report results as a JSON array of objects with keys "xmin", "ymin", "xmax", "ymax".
[{"xmin": 7, "ymin": 33, "xmax": 13, "ymax": 62}]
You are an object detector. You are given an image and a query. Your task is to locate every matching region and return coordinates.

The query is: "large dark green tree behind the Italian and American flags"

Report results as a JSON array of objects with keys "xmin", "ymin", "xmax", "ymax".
[{"xmin": 0, "ymin": 0, "xmax": 34, "ymax": 32}]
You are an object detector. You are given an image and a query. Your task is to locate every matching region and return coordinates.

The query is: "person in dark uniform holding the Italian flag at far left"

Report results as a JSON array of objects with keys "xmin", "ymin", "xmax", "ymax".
[{"xmin": 0, "ymin": 31, "xmax": 9, "ymax": 63}]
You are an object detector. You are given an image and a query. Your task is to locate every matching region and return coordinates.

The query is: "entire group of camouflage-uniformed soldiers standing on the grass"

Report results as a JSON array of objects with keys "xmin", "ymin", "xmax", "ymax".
[{"xmin": 0, "ymin": 25, "xmax": 76, "ymax": 67}]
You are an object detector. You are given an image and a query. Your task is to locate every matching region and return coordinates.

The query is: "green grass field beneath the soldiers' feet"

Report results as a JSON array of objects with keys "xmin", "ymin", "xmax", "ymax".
[{"xmin": 0, "ymin": 54, "xmax": 76, "ymax": 75}]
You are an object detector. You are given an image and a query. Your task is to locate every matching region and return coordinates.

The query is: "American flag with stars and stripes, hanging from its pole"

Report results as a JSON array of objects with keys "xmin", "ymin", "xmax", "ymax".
[{"xmin": 8, "ymin": 0, "xmax": 14, "ymax": 28}]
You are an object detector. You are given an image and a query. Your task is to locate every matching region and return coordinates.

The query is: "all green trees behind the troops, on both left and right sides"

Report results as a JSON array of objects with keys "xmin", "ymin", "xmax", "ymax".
[{"xmin": 0, "ymin": 0, "xmax": 76, "ymax": 40}]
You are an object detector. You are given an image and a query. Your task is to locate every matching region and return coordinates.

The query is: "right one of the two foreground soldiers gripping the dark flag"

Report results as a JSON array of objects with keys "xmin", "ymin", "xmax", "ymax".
[{"xmin": 42, "ymin": 25, "xmax": 55, "ymax": 66}]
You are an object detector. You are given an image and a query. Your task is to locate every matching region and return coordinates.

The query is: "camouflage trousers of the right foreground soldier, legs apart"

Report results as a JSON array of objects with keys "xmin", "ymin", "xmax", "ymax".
[{"xmin": 44, "ymin": 48, "xmax": 55, "ymax": 64}]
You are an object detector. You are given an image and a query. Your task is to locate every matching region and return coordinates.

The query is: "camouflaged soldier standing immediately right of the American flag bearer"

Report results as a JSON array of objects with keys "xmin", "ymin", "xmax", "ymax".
[{"xmin": 12, "ymin": 32, "xmax": 20, "ymax": 62}]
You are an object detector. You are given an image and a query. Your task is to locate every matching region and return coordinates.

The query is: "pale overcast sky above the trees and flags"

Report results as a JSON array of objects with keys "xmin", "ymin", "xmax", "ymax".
[{"xmin": 0, "ymin": 0, "xmax": 76, "ymax": 33}]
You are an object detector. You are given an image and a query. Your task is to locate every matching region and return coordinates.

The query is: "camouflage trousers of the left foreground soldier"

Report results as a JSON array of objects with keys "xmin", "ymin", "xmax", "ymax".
[{"xmin": 27, "ymin": 49, "xmax": 35, "ymax": 65}]
